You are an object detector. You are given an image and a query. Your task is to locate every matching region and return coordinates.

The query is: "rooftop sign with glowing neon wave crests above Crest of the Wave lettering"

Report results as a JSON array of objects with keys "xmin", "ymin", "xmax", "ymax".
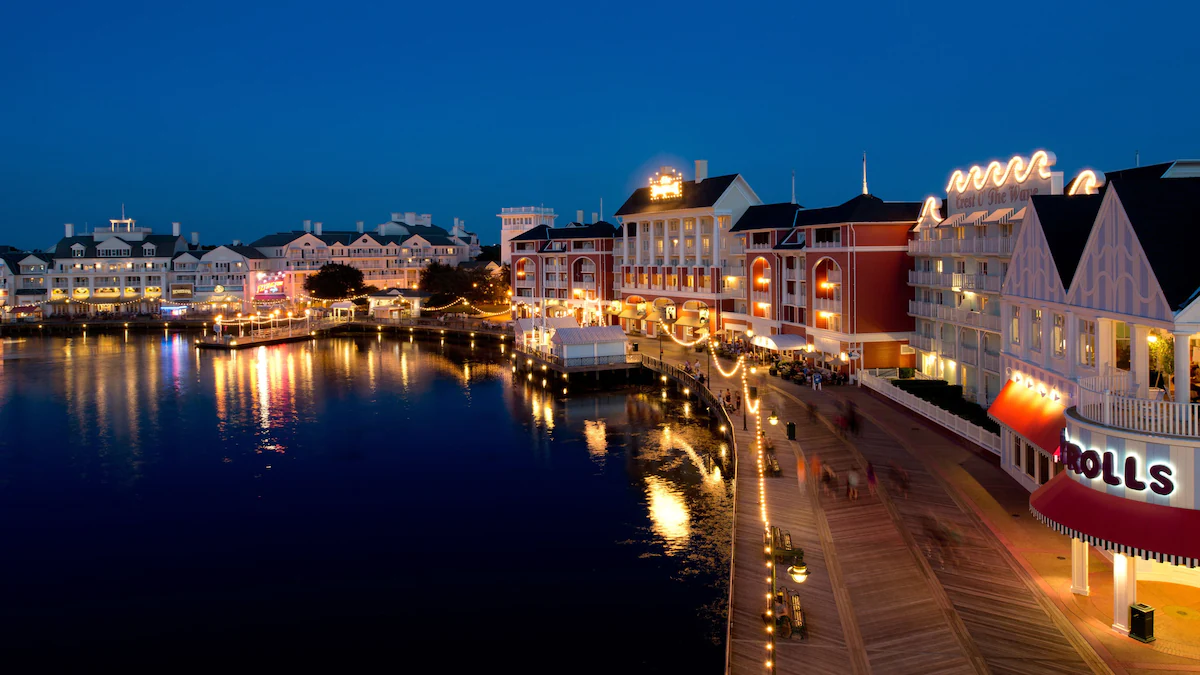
[{"xmin": 946, "ymin": 150, "xmax": 1062, "ymax": 215}]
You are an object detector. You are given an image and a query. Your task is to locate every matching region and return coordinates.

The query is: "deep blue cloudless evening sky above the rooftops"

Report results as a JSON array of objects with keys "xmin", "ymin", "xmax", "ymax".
[{"xmin": 0, "ymin": 0, "xmax": 1200, "ymax": 247}]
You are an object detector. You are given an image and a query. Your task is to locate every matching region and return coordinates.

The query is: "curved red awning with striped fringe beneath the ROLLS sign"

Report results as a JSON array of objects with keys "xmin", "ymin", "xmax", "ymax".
[{"xmin": 1030, "ymin": 471, "xmax": 1200, "ymax": 567}]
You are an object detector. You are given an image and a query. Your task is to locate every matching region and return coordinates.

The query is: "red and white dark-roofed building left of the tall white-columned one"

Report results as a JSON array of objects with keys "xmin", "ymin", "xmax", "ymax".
[{"xmin": 509, "ymin": 211, "xmax": 617, "ymax": 325}]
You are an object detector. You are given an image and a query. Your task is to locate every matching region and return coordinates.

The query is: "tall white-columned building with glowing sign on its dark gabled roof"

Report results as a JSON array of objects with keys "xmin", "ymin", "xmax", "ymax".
[{"xmin": 613, "ymin": 160, "xmax": 762, "ymax": 340}]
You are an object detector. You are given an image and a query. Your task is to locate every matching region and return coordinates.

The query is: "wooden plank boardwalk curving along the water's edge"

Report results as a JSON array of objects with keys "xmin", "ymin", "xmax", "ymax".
[{"xmin": 641, "ymin": 339, "xmax": 1200, "ymax": 675}]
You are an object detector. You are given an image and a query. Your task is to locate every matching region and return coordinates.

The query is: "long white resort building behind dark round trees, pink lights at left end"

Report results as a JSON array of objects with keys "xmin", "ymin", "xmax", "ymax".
[{"xmin": 250, "ymin": 211, "xmax": 478, "ymax": 303}]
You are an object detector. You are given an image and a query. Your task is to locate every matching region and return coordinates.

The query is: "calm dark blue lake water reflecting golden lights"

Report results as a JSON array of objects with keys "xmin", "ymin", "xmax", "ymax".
[{"xmin": 0, "ymin": 334, "xmax": 732, "ymax": 673}]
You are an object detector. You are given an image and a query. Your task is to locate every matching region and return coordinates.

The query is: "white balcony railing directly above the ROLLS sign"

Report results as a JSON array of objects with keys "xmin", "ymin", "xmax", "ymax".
[{"xmin": 1075, "ymin": 374, "xmax": 1200, "ymax": 437}]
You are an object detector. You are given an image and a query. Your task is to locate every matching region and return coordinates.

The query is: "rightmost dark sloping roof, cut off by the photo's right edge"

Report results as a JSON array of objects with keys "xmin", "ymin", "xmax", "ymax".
[{"xmin": 1109, "ymin": 174, "xmax": 1200, "ymax": 310}]
